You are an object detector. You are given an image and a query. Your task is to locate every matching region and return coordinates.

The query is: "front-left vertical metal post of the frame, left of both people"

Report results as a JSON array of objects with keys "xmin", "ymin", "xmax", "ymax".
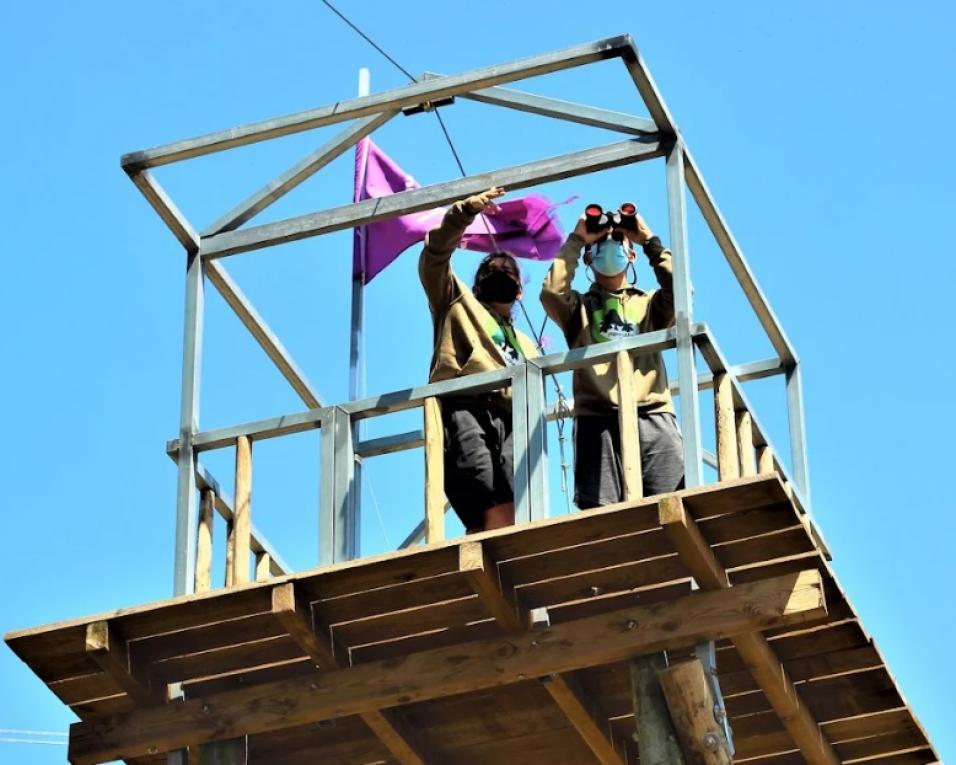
[{"xmin": 173, "ymin": 251, "xmax": 203, "ymax": 595}]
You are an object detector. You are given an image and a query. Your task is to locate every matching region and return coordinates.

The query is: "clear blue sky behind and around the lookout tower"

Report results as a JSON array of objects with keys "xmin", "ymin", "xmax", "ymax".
[{"xmin": 0, "ymin": 0, "xmax": 956, "ymax": 763}]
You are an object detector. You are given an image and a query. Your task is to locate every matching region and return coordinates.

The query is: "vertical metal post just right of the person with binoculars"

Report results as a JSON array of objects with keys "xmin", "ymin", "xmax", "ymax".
[{"xmin": 667, "ymin": 141, "xmax": 704, "ymax": 487}]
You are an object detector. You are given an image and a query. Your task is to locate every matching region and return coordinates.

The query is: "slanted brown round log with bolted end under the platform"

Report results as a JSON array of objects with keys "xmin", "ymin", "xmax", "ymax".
[{"xmin": 658, "ymin": 659, "xmax": 732, "ymax": 765}]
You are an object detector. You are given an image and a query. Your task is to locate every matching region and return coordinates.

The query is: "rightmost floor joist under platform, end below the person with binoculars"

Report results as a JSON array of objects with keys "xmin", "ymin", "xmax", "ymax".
[{"xmin": 658, "ymin": 497, "xmax": 840, "ymax": 765}]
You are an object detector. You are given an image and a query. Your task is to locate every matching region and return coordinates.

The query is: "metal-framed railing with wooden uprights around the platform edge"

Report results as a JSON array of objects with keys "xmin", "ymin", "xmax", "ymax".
[{"xmin": 168, "ymin": 325, "xmax": 820, "ymax": 590}]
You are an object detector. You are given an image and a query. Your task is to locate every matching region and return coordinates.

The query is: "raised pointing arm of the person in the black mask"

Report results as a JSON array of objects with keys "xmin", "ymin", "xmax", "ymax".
[{"xmin": 418, "ymin": 186, "xmax": 505, "ymax": 314}]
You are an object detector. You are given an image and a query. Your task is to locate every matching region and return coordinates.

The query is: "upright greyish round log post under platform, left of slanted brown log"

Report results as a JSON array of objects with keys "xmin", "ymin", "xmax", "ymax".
[{"xmin": 631, "ymin": 653, "xmax": 684, "ymax": 765}]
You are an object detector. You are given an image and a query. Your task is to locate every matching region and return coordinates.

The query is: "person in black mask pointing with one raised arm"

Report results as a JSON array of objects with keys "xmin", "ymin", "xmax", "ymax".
[{"xmin": 418, "ymin": 187, "xmax": 537, "ymax": 533}]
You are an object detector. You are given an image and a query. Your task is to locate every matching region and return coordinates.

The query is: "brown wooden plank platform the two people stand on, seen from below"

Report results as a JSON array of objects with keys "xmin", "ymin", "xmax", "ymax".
[{"xmin": 6, "ymin": 476, "xmax": 937, "ymax": 765}]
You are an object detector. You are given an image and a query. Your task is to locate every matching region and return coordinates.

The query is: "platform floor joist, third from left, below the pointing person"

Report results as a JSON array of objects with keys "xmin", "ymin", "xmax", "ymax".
[{"xmin": 459, "ymin": 542, "xmax": 626, "ymax": 765}]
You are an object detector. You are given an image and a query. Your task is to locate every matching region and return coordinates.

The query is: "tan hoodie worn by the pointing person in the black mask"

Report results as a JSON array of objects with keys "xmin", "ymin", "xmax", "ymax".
[{"xmin": 418, "ymin": 202, "xmax": 538, "ymax": 409}]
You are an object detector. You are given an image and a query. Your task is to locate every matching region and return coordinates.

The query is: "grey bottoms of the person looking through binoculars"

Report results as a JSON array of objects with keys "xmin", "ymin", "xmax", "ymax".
[{"xmin": 574, "ymin": 409, "xmax": 684, "ymax": 510}]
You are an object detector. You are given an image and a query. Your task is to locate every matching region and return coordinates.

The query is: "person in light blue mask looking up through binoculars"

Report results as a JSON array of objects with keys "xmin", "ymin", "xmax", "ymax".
[{"xmin": 541, "ymin": 202, "xmax": 684, "ymax": 510}]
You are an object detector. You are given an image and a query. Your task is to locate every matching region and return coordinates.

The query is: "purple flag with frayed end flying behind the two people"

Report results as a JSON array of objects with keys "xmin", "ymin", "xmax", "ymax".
[{"xmin": 352, "ymin": 138, "xmax": 564, "ymax": 284}]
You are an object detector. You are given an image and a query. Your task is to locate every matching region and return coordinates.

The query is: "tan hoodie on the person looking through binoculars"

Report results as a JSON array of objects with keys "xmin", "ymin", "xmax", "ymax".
[{"xmin": 541, "ymin": 234, "xmax": 674, "ymax": 415}]
